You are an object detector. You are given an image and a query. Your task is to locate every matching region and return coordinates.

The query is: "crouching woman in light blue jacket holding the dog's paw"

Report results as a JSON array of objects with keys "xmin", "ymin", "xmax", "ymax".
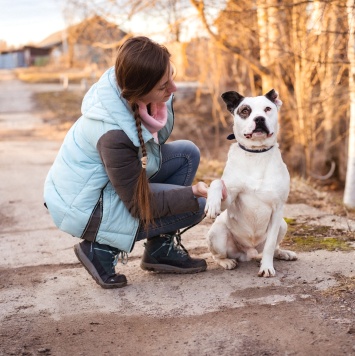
[{"xmin": 44, "ymin": 37, "xmax": 211, "ymax": 288}]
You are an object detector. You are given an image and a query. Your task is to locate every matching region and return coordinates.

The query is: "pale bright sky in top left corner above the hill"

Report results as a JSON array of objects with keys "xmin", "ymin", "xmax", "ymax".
[{"xmin": 0, "ymin": 0, "xmax": 66, "ymax": 47}]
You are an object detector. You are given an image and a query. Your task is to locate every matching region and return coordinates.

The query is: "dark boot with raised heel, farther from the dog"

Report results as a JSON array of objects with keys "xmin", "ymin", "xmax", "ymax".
[{"xmin": 74, "ymin": 240, "xmax": 127, "ymax": 288}]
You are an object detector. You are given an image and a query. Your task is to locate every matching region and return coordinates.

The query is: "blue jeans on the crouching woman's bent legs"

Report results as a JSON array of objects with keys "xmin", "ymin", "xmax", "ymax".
[{"xmin": 137, "ymin": 140, "xmax": 206, "ymax": 240}]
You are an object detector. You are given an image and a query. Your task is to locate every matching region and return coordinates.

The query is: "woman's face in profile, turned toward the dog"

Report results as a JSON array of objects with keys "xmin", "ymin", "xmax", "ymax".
[{"xmin": 140, "ymin": 65, "xmax": 176, "ymax": 105}]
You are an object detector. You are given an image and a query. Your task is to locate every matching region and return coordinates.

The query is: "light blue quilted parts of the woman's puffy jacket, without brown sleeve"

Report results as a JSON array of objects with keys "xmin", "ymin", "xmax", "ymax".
[{"xmin": 44, "ymin": 67, "xmax": 174, "ymax": 252}]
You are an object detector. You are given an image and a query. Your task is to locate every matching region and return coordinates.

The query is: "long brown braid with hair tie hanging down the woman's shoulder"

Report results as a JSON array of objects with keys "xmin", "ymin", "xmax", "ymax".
[{"xmin": 132, "ymin": 104, "xmax": 153, "ymax": 227}]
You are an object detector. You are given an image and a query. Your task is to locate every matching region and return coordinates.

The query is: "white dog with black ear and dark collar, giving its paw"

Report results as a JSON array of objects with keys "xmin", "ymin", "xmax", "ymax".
[{"xmin": 205, "ymin": 89, "xmax": 297, "ymax": 277}]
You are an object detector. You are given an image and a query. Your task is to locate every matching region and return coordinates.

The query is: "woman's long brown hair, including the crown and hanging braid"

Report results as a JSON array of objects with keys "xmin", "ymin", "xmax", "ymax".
[{"xmin": 115, "ymin": 36, "xmax": 170, "ymax": 226}]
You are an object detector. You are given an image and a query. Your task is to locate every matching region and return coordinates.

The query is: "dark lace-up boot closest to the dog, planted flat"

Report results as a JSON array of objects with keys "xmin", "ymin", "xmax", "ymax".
[{"xmin": 141, "ymin": 232, "xmax": 207, "ymax": 273}]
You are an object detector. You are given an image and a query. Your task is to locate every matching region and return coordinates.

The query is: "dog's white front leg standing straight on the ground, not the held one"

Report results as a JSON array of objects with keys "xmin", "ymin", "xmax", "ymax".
[{"xmin": 258, "ymin": 207, "xmax": 283, "ymax": 277}]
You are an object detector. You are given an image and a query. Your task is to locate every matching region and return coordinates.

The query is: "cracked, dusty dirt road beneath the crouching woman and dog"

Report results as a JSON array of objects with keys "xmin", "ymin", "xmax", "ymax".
[{"xmin": 0, "ymin": 72, "xmax": 355, "ymax": 356}]
